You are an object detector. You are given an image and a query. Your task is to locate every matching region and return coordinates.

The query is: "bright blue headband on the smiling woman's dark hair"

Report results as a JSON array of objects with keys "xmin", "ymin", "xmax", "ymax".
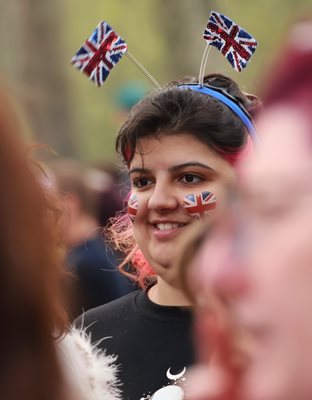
[{"xmin": 177, "ymin": 83, "xmax": 258, "ymax": 143}]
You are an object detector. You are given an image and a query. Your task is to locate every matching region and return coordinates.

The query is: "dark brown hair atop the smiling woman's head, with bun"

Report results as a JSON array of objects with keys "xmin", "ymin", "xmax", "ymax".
[{"xmin": 116, "ymin": 74, "xmax": 260, "ymax": 163}]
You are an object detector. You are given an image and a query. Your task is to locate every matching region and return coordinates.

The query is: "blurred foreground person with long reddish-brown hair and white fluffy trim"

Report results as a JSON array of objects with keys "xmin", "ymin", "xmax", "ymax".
[{"xmin": 0, "ymin": 87, "xmax": 120, "ymax": 400}]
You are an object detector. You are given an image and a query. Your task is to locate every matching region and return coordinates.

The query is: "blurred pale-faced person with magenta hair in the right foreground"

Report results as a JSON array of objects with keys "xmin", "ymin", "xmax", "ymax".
[{"xmin": 180, "ymin": 20, "xmax": 312, "ymax": 400}]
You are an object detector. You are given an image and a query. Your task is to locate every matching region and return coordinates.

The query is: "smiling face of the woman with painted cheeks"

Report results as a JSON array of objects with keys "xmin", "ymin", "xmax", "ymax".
[{"xmin": 129, "ymin": 134, "xmax": 235, "ymax": 284}]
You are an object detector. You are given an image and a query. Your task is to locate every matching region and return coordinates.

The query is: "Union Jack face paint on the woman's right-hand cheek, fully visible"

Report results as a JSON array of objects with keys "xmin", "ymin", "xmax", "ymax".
[{"xmin": 182, "ymin": 192, "xmax": 217, "ymax": 220}]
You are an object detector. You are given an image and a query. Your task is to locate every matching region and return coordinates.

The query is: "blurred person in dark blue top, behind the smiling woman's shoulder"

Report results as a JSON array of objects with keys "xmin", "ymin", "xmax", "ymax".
[{"xmin": 47, "ymin": 158, "xmax": 135, "ymax": 320}]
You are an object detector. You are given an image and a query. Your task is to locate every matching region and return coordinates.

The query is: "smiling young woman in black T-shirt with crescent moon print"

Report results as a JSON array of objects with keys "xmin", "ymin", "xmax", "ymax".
[{"xmin": 78, "ymin": 74, "xmax": 257, "ymax": 400}]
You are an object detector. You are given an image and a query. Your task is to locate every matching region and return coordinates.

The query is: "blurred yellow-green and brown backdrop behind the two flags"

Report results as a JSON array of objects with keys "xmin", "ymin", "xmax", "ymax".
[{"xmin": 0, "ymin": 0, "xmax": 312, "ymax": 163}]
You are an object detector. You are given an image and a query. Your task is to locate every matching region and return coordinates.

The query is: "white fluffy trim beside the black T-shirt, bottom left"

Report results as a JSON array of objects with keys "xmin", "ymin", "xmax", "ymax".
[{"xmin": 57, "ymin": 327, "xmax": 121, "ymax": 400}]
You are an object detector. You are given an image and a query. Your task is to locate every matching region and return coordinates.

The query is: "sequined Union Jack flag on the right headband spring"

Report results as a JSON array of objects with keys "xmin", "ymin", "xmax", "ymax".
[{"xmin": 203, "ymin": 11, "xmax": 258, "ymax": 72}]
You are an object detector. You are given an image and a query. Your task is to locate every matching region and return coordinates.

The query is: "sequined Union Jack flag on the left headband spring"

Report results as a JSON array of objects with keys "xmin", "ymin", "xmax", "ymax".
[{"xmin": 71, "ymin": 21, "xmax": 128, "ymax": 86}]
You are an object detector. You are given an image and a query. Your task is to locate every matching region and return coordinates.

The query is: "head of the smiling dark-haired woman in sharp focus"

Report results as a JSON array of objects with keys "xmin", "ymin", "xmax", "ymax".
[{"xmin": 107, "ymin": 75, "xmax": 258, "ymax": 283}]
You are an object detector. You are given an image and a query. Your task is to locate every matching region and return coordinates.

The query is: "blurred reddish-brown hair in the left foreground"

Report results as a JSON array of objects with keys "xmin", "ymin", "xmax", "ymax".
[{"xmin": 0, "ymin": 87, "xmax": 66, "ymax": 400}]
